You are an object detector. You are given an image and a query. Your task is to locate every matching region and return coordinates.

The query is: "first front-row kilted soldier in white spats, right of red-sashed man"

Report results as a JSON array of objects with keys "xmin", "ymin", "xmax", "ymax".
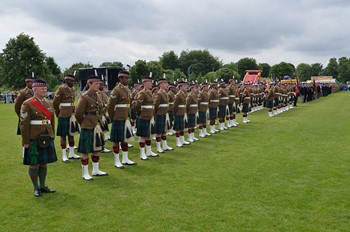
[{"xmin": 75, "ymin": 76, "xmax": 108, "ymax": 180}]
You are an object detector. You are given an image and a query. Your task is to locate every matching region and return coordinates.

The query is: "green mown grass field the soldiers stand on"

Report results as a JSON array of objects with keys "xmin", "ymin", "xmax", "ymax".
[{"xmin": 0, "ymin": 92, "xmax": 350, "ymax": 231}]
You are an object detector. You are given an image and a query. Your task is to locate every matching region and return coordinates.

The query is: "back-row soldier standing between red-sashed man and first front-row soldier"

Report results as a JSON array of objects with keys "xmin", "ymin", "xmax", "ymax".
[{"xmin": 53, "ymin": 74, "xmax": 80, "ymax": 163}]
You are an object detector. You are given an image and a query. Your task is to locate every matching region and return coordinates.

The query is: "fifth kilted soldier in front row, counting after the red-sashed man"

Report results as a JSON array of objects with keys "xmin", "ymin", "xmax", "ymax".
[{"xmin": 173, "ymin": 81, "xmax": 190, "ymax": 147}]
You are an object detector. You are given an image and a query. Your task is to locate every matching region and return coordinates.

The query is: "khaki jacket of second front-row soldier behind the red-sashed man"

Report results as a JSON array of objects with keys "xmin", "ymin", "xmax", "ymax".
[{"xmin": 108, "ymin": 83, "xmax": 130, "ymax": 121}]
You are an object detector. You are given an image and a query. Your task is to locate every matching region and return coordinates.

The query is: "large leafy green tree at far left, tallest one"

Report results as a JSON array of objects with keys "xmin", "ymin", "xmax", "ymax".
[{"xmin": 0, "ymin": 33, "xmax": 52, "ymax": 89}]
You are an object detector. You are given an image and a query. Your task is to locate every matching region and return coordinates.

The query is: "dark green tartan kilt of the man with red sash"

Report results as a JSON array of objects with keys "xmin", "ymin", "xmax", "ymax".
[{"xmin": 23, "ymin": 139, "xmax": 57, "ymax": 165}]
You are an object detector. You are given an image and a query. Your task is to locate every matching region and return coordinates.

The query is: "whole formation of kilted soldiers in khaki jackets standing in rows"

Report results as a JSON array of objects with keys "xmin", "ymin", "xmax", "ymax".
[{"xmin": 15, "ymin": 70, "xmax": 320, "ymax": 197}]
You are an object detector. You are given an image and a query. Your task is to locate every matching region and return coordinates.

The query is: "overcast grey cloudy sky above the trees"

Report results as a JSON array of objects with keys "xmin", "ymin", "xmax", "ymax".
[{"xmin": 0, "ymin": 0, "xmax": 350, "ymax": 70}]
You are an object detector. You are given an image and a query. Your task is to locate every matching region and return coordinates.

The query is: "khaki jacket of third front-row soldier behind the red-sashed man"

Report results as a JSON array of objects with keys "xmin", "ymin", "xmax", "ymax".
[{"xmin": 135, "ymin": 90, "xmax": 154, "ymax": 120}]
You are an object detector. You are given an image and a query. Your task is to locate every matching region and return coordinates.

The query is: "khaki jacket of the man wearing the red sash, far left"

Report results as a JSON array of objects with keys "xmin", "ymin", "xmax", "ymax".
[{"xmin": 20, "ymin": 97, "xmax": 55, "ymax": 144}]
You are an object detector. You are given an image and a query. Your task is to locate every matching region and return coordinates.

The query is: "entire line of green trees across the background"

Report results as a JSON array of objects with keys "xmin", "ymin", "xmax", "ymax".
[{"xmin": 0, "ymin": 33, "xmax": 350, "ymax": 89}]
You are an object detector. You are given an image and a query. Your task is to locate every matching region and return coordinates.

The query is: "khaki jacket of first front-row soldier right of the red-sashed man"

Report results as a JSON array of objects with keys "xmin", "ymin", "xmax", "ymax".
[{"xmin": 75, "ymin": 89, "xmax": 103, "ymax": 129}]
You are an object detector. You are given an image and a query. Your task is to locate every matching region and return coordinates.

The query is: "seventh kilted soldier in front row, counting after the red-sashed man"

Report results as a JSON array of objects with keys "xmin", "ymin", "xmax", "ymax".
[{"xmin": 198, "ymin": 82, "xmax": 211, "ymax": 138}]
